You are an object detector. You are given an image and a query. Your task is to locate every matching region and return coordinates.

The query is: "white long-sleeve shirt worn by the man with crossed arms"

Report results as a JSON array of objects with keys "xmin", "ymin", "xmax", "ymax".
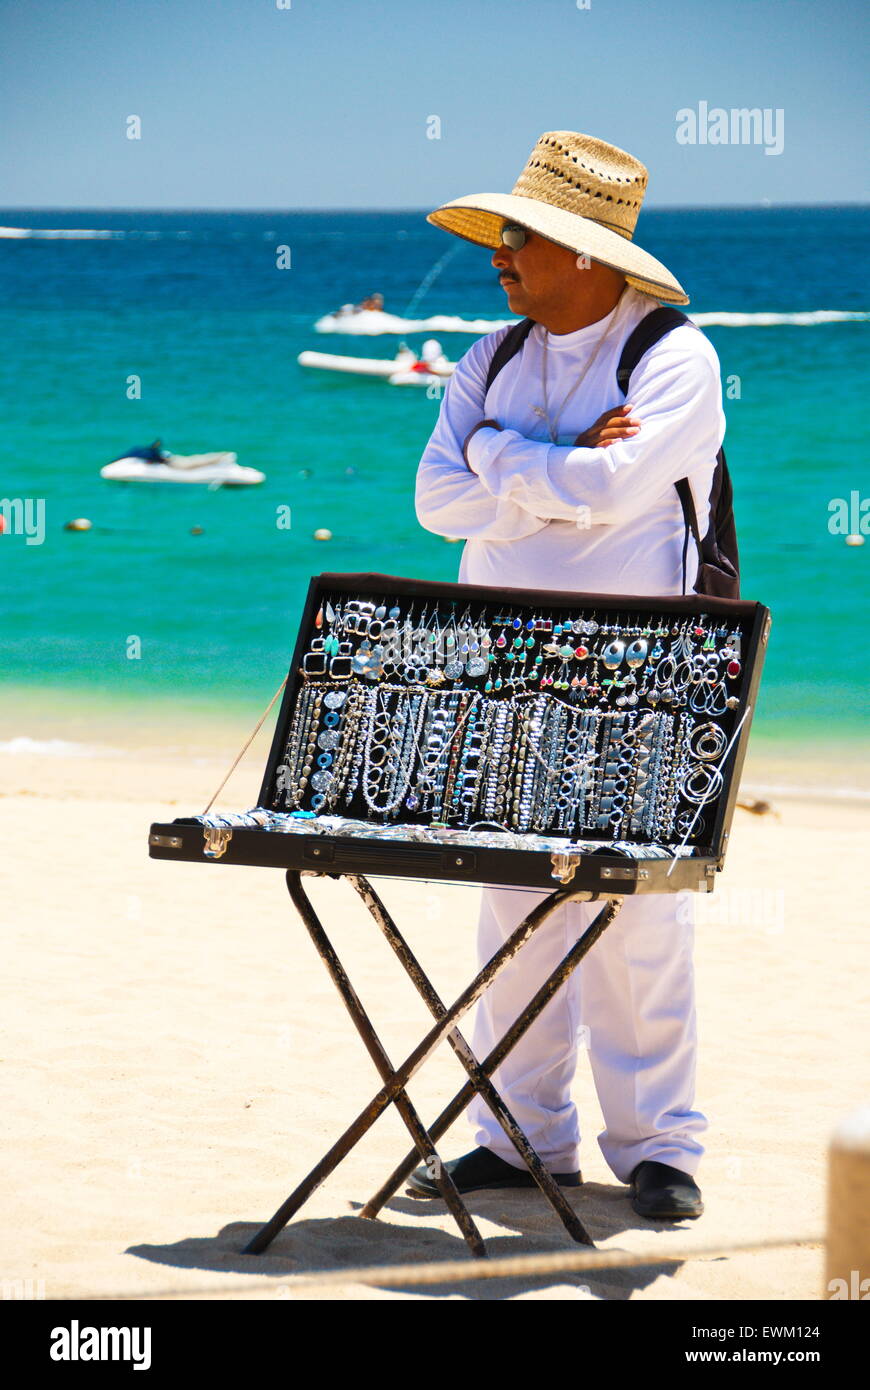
[{"xmin": 416, "ymin": 286, "xmax": 725, "ymax": 595}]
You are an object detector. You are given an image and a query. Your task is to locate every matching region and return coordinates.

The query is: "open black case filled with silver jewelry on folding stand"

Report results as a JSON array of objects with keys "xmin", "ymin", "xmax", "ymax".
[{"xmin": 149, "ymin": 574, "xmax": 770, "ymax": 894}]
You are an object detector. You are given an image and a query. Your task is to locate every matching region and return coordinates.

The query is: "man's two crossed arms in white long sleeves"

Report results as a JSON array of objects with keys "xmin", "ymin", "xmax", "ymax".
[{"xmin": 417, "ymin": 329, "xmax": 724, "ymax": 539}]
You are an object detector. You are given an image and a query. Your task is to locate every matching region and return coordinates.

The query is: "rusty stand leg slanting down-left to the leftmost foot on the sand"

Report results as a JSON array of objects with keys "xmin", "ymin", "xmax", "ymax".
[{"xmin": 243, "ymin": 870, "xmax": 589, "ymax": 1255}]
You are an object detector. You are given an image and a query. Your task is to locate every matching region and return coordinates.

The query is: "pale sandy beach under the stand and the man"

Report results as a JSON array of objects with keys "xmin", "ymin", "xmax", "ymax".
[{"xmin": 0, "ymin": 706, "xmax": 870, "ymax": 1300}]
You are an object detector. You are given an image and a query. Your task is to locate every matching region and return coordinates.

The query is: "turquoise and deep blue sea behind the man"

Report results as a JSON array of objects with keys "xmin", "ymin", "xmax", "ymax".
[{"xmin": 0, "ymin": 207, "xmax": 870, "ymax": 767}]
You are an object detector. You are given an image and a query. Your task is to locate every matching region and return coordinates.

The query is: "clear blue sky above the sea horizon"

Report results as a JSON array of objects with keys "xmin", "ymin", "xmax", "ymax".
[{"xmin": 0, "ymin": 0, "xmax": 870, "ymax": 209}]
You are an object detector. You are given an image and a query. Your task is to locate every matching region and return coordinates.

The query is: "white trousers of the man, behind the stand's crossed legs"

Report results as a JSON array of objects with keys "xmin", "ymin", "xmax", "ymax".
[{"xmin": 467, "ymin": 888, "xmax": 707, "ymax": 1183}]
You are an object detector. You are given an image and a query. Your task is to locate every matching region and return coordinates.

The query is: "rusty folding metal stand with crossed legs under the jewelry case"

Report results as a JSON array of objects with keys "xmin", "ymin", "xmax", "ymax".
[{"xmin": 245, "ymin": 869, "xmax": 623, "ymax": 1258}]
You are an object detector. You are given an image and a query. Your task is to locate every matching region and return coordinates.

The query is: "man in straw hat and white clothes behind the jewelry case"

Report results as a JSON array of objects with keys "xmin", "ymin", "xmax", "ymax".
[{"xmin": 410, "ymin": 131, "xmax": 724, "ymax": 1219}]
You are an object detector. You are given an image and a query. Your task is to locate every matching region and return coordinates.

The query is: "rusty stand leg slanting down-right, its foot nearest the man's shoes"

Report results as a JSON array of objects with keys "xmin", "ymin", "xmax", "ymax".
[{"xmin": 347, "ymin": 874, "xmax": 591, "ymax": 1245}]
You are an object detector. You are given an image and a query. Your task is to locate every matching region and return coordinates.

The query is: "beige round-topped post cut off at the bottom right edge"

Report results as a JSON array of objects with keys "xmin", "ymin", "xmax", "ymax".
[{"xmin": 821, "ymin": 1105, "xmax": 870, "ymax": 1300}]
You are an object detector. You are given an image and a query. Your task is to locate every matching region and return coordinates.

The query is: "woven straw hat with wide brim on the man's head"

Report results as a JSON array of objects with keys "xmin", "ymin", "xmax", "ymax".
[{"xmin": 427, "ymin": 131, "xmax": 689, "ymax": 304}]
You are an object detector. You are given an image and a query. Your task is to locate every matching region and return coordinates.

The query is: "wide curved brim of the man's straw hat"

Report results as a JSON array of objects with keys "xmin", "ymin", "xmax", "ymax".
[{"xmin": 427, "ymin": 193, "xmax": 689, "ymax": 304}]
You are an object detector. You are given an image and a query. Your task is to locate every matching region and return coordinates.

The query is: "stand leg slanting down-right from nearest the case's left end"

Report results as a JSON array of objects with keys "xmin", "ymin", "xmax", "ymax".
[{"xmin": 280, "ymin": 869, "xmax": 486, "ymax": 1258}]
